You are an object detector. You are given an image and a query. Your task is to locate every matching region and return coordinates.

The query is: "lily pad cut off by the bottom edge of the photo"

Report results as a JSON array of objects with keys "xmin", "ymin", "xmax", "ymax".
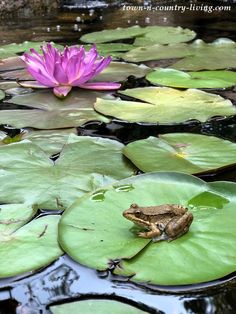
[{"xmin": 50, "ymin": 299, "xmax": 147, "ymax": 314}]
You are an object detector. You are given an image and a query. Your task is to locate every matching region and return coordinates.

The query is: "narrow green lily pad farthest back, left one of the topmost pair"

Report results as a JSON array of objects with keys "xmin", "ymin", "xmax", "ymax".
[{"xmin": 80, "ymin": 26, "xmax": 146, "ymax": 44}]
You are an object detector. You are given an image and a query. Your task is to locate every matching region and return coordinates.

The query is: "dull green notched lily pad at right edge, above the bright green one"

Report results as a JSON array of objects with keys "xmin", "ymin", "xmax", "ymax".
[{"xmin": 123, "ymin": 39, "xmax": 236, "ymax": 71}]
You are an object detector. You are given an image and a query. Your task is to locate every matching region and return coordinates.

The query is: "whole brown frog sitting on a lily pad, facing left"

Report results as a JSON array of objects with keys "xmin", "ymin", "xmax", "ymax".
[{"xmin": 123, "ymin": 204, "xmax": 193, "ymax": 241}]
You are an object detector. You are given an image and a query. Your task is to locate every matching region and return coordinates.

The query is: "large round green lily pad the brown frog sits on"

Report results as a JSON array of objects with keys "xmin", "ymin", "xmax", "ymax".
[{"xmin": 59, "ymin": 172, "xmax": 236, "ymax": 285}]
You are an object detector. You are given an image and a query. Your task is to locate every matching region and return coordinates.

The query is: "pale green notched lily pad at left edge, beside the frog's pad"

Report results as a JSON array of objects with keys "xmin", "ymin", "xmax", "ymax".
[{"xmin": 0, "ymin": 204, "xmax": 63, "ymax": 278}]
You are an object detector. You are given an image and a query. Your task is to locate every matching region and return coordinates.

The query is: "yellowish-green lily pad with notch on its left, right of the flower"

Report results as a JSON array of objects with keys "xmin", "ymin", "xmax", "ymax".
[{"xmin": 94, "ymin": 87, "xmax": 236, "ymax": 124}]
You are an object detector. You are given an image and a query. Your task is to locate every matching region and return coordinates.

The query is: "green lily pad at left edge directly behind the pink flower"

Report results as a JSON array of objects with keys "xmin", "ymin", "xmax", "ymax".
[{"xmin": 0, "ymin": 41, "xmax": 63, "ymax": 59}]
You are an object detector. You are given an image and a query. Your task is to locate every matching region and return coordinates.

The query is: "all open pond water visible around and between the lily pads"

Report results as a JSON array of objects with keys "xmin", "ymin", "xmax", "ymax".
[{"xmin": 0, "ymin": 5, "xmax": 236, "ymax": 314}]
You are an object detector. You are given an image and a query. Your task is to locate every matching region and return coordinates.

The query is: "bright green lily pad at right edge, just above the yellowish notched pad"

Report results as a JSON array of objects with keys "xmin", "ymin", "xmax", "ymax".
[{"xmin": 146, "ymin": 68, "xmax": 236, "ymax": 88}]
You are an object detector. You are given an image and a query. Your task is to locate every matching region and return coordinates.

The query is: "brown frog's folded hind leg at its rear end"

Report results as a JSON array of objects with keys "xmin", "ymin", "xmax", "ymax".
[{"xmin": 165, "ymin": 212, "xmax": 193, "ymax": 240}]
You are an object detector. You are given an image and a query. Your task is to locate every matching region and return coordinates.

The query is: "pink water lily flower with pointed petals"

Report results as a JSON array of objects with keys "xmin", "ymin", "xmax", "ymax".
[{"xmin": 21, "ymin": 43, "xmax": 120, "ymax": 98}]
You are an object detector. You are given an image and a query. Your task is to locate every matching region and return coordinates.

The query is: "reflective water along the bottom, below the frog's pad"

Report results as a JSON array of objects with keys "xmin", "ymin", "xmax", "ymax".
[{"xmin": 0, "ymin": 256, "xmax": 236, "ymax": 314}]
